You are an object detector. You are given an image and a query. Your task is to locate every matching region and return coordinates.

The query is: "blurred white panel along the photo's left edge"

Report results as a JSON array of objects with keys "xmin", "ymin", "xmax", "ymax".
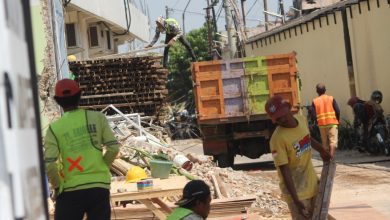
[{"xmin": 0, "ymin": 0, "xmax": 48, "ymax": 220}]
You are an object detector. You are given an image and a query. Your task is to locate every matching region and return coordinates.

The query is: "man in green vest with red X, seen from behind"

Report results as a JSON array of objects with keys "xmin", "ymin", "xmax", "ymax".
[{"xmin": 44, "ymin": 79, "xmax": 119, "ymax": 220}]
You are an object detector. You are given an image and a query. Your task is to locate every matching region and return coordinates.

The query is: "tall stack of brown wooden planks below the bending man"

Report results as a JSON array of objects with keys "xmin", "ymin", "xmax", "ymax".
[{"xmin": 69, "ymin": 56, "xmax": 168, "ymax": 115}]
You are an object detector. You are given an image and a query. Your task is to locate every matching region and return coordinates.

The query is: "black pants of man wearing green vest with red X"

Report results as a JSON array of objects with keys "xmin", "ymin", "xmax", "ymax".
[{"xmin": 54, "ymin": 188, "xmax": 111, "ymax": 220}]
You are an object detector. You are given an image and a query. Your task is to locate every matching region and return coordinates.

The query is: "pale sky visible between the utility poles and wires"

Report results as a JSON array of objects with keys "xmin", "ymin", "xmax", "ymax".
[{"xmin": 146, "ymin": 0, "xmax": 292, "ymax": 37}]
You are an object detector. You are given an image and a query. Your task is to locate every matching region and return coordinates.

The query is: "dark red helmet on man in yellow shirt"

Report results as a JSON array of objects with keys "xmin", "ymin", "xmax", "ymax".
[{"xmin": 265, "ymin": 95, "xmax": 291, "ymax": 123}]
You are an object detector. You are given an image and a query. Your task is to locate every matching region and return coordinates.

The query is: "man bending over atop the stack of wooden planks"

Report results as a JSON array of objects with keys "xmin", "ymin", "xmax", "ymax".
[{"xmin": 146, "ymin": 16, "xmax": 196, "ymax": 67}]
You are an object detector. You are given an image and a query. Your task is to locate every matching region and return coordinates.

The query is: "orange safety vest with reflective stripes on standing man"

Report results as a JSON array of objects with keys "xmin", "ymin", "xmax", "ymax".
[{"xmin": 313, "ymin": 94, "xmax": 339, "ymax": 126}]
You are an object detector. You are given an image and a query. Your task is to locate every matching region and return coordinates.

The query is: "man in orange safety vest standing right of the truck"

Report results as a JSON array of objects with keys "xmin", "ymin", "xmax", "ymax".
[{"xmin": 312, "ymin": 83, "xmax": 340, "ymax": 158}]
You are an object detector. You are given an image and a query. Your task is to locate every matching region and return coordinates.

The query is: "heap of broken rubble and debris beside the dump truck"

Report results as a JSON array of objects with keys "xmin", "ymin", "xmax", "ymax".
[{"xmin": 108, "ymin": 110, "xmax": 288, "ymax": 217}]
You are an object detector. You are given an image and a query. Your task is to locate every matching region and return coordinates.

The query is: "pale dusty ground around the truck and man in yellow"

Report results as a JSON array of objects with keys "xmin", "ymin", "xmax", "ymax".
[{"xmin": 173, "ymin": 139, "xmax": 390, "ymax": 219}]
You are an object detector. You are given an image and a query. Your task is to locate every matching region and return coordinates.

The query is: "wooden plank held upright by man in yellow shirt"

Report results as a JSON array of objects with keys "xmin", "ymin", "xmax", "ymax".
[{"xmin": 312, "ymin": 161, "xmax": 336, "ymax": 220}]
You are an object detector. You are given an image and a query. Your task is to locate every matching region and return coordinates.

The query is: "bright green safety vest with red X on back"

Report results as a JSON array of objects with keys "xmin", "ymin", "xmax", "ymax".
[{"xmin": 50, "ymin": 109, "xmax": 111, "ymax": 191}]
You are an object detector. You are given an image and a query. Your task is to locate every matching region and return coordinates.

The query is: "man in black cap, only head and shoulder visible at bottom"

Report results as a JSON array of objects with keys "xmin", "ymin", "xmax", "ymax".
[{"xmin": 167, "ymin": 180, "xmax": 211, "ymax": 220}]
